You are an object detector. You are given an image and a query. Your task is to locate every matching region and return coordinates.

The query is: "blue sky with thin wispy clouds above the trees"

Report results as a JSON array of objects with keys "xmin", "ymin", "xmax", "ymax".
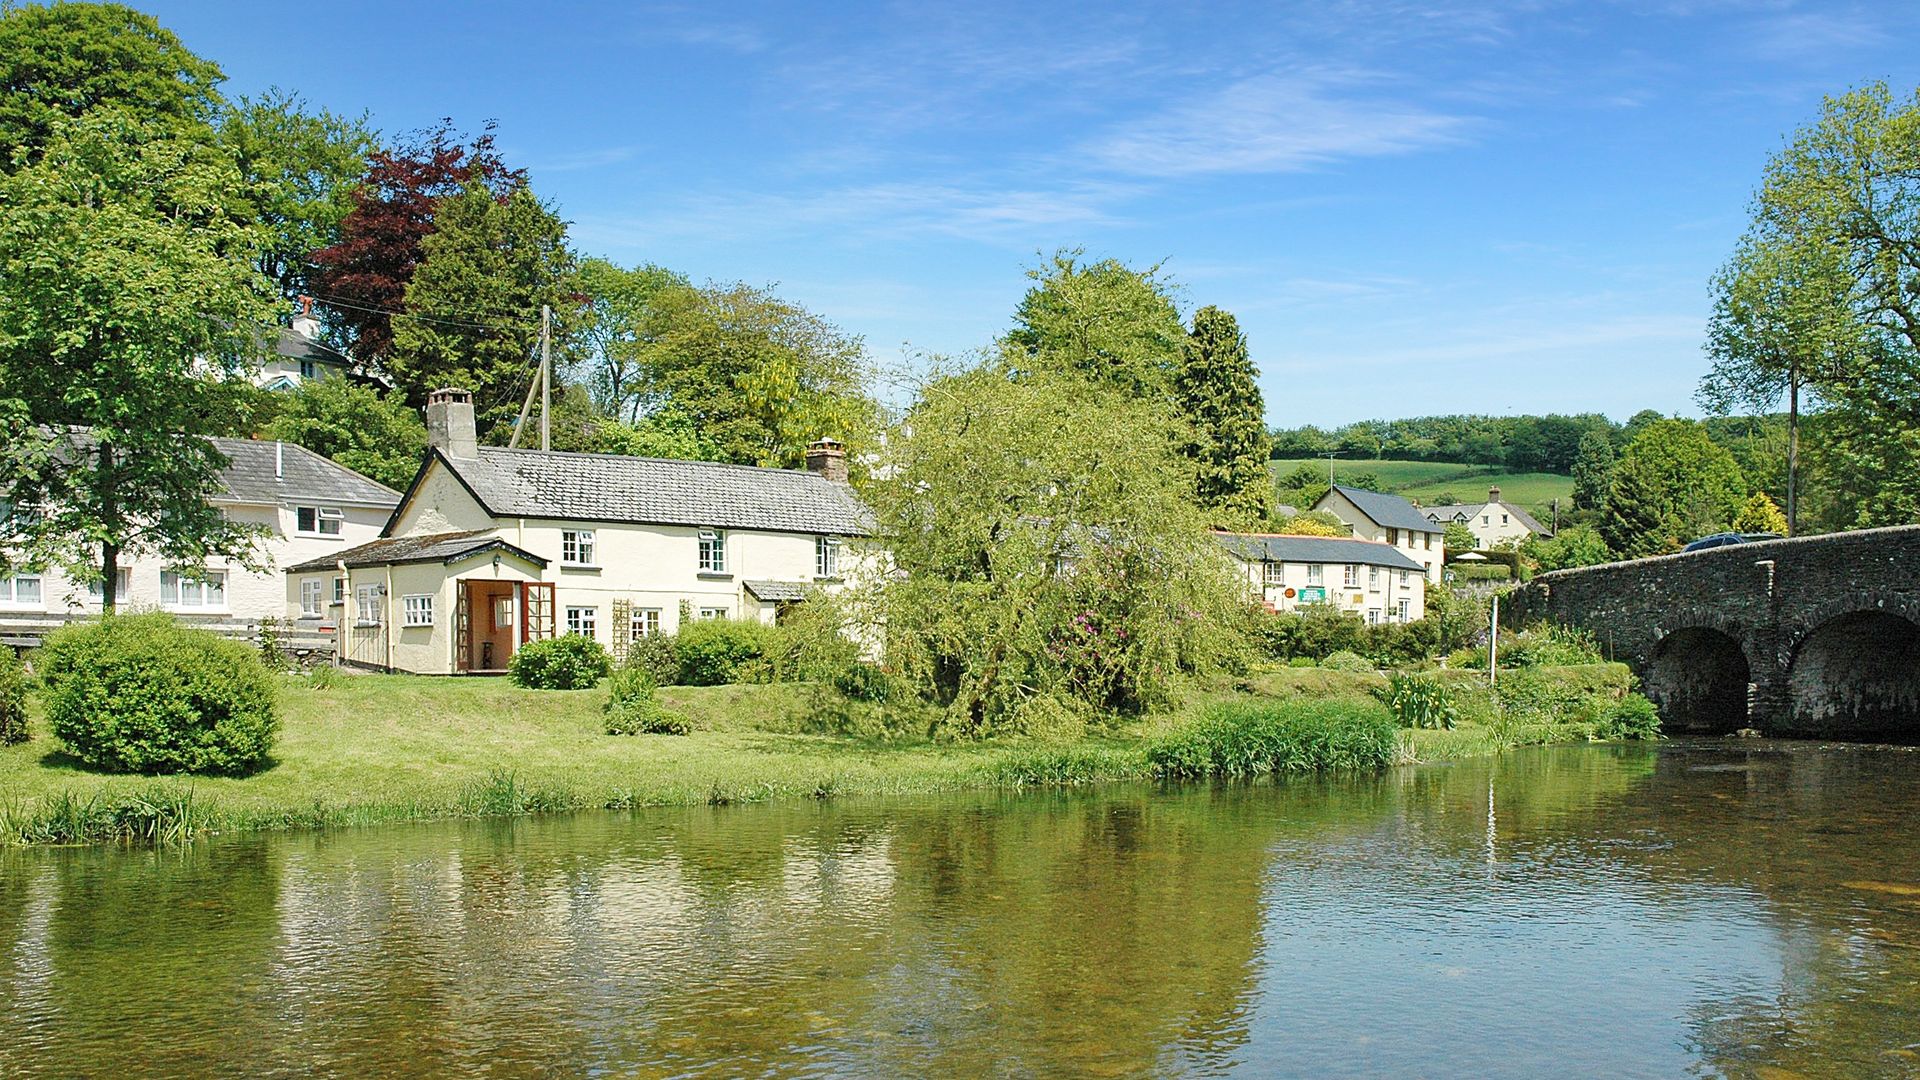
[{"xmin": 148, "ymin": 0, "xmax": 1920, "ymax": 425}]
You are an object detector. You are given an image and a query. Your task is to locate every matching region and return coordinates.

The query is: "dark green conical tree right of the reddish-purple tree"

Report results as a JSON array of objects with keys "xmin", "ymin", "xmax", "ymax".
[{"xmin": 386, "ymin": 181, "xmax": 574, "ymax": 434}]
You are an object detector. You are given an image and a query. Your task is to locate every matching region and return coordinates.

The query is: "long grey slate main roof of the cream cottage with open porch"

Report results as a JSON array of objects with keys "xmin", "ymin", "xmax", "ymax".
[{"xmin": 436, "ymin": 446, "xmax": 874, "ymax": 536}]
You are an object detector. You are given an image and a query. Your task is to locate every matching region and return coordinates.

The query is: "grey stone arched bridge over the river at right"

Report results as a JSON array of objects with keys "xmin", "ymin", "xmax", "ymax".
[{"xmin": 1501, "ymin": 525, "xmax": 1920, "ymax": 744}]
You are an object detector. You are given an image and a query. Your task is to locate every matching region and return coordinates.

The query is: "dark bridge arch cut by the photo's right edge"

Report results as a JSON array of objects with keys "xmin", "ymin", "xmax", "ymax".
[{"xmin": 1784, "ymin": 609, "xmax": 1920, "ymax": 744}]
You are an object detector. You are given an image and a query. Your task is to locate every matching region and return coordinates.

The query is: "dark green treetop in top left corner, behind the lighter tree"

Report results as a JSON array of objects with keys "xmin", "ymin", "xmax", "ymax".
[{"xmin": 0, "ymin": 4, "xmax": 225, "ymax": 171}]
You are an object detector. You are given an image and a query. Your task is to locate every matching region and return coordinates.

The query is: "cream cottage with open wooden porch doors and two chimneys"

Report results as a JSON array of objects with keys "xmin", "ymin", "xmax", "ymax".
[{"xmin": 284, "ymin": 390, "xmax": 872, "ymax": 675}]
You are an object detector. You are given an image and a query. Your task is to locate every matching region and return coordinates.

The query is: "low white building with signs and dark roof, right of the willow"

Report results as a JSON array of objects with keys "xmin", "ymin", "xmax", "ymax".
[{"xmin": 1219, "ymin": 532, "xmax": 1427, "ymax": 623}]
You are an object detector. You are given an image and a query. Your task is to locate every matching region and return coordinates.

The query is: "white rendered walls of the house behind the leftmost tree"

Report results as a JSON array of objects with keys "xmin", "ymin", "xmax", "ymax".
[{"xmin": 0, "ymin": 502, "xmax": 392, "ymax": 623}]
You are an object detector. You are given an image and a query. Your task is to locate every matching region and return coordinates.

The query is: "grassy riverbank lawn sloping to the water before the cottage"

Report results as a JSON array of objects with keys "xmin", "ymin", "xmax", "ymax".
[{"xmin": 0, "ymin": 665, "xmax": 1624, "ymax": 844}]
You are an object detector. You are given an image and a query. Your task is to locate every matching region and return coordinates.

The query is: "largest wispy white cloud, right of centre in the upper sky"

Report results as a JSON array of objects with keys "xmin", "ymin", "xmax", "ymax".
[{"xmin": 1085, "ymin": 71, "xmax": 1469, "ymax": 177}]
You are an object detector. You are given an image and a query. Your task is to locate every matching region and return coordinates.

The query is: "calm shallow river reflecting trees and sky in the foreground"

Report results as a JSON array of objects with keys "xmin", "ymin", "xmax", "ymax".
[{"xmin": 0, "ymin": 742, "xmax": 1920, "ymax": 1078}]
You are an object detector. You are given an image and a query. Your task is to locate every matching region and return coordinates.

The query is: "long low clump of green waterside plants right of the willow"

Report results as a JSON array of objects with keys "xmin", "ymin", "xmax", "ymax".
[{"xmin": 1148, "ymin": 701, "xmax": 1400, "ymax": 780}]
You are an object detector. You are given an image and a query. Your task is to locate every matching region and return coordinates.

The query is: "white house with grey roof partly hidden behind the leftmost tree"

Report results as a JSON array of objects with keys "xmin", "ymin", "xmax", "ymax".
[{"xmin": 0, "ymin": 438, "xmax": 399, "ymax": 630}]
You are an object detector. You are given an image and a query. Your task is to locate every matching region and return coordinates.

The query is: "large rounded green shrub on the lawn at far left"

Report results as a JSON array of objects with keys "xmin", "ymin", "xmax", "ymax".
[{"xmin": 40, "ymin": 613, "xmax": 280, "ymax": 773}]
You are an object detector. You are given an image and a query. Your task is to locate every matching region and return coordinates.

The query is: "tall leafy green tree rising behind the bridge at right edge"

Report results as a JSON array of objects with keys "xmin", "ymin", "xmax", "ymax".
[{"xmin": 1707, "ymin": 83, "xmax": 1920, "ymax": 525}]
